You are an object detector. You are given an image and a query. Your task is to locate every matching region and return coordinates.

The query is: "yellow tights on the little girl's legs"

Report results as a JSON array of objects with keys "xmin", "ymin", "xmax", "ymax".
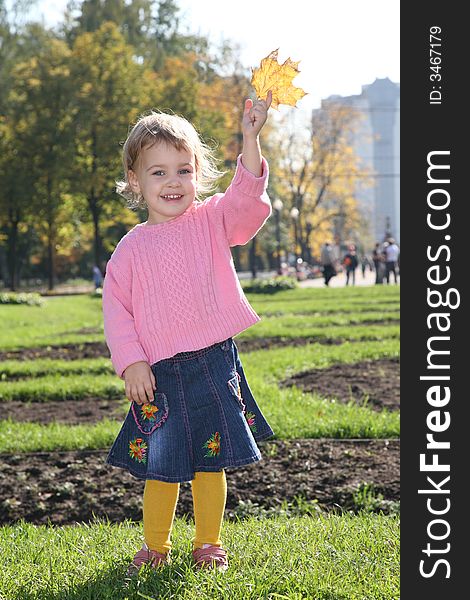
[{"xmin": 143, "ymin": 471, "xmax": 227, "ymax": 554}]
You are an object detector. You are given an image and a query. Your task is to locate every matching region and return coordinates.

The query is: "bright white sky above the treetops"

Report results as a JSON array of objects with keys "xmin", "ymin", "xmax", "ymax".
[{"xmin": 28, "ymin": 0, "xmax": 400, "ymax": 112}]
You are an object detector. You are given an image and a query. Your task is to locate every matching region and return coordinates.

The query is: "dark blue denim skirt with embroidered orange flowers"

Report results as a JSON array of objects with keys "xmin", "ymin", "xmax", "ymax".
[{"xmin": 106, "ymin": 338, "xmax": 273, "ymax": 483}]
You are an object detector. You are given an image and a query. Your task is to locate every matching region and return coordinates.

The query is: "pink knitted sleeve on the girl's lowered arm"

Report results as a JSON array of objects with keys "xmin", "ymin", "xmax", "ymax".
[{"xmin": 103, "ymin": 254, "xmax": 148, "ymax": 379}]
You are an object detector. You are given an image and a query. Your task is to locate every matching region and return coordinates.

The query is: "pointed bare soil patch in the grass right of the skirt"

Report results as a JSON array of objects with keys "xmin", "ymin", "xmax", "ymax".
[{"xmin": 279, "ymin": 358, "xmax": 400, "ymax": 410}]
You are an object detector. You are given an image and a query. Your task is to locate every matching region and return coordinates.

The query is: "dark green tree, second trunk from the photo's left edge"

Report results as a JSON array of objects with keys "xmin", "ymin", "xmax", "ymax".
[{"xmin": 10, "ymin": 39, "xmax": 73, "ymax": 289}]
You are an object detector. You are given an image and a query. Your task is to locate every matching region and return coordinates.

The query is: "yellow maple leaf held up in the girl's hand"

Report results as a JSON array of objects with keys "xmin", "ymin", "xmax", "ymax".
[{"xmin": 251, "ymin": 48, "xmax": 307, "ymax": 109}]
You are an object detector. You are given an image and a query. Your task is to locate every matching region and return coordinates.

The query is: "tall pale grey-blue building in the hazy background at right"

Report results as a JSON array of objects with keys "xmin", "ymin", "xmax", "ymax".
[{"xmin": 319, "ymin": 77, "xmax": 400, "ymax": 242}]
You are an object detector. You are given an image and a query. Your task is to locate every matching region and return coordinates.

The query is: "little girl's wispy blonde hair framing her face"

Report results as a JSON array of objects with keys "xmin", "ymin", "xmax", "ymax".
[{"xmin": 116, "ymin": 111, "xmax": 224, "ymax": 208}]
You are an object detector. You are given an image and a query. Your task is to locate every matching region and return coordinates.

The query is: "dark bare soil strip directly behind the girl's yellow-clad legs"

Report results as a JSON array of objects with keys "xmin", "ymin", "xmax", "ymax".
[{"xmin": 0, "ymin": 439, "xmax": 400, "ymax": 525}]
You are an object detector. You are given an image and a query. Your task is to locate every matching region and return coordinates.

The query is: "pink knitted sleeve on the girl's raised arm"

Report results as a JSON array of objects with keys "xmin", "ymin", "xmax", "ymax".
[{"xmin": 205, "ymin": 155, "xmax": 272, "ymax": 246}]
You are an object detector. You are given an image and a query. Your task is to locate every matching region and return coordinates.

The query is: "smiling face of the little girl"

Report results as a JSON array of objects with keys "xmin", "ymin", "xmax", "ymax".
[{"xmin": 128, "ymin": 142, "xmax": 196, "ymax": 225}]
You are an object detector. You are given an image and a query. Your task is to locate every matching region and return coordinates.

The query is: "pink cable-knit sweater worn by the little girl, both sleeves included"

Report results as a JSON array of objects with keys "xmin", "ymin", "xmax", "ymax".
[{"xmin": 103, "ymin": 157, "xmax": 271, "ymax": 378}]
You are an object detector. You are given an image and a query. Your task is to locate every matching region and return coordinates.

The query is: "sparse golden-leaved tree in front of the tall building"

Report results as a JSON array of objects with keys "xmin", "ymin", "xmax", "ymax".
[{"xmin": 278, "ymin": 102, "xmax": 363, "ymax": 260}]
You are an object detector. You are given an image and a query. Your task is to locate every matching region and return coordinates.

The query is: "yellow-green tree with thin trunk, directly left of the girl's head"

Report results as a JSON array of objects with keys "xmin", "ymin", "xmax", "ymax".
[{"xmin": 71, "ymin": 22, "xmax": 158, "ymax": 265}]
